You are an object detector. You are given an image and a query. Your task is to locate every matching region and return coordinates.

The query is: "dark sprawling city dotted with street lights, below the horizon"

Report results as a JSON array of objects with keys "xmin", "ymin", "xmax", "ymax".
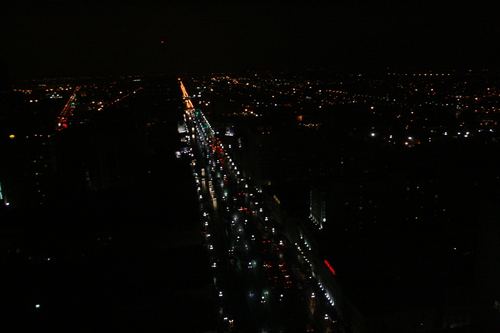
[{"xmin": 0, "ymin": 70, "xmax": 500, "ymax": 333}]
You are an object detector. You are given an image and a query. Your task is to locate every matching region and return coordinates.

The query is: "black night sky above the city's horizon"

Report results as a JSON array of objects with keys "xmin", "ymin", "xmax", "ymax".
[{"xmin": 0, "ymin": 0, "xmax": 500, "ymax": 78}]
